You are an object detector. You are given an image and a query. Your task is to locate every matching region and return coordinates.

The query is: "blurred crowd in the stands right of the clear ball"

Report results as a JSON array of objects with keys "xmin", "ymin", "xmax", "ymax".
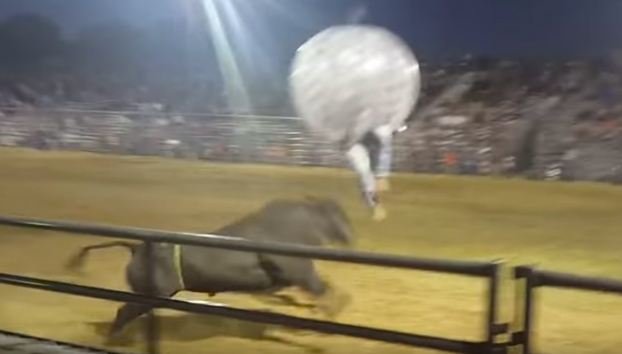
[{"xmin": 404, "ymin": 56, "xmax": 622, "ymax": 182}]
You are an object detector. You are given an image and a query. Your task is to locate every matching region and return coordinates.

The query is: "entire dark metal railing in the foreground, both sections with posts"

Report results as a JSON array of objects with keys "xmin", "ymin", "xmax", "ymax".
[{"xmin": 0, "ymin": 216, "xmax": 622, "ymax": 354}]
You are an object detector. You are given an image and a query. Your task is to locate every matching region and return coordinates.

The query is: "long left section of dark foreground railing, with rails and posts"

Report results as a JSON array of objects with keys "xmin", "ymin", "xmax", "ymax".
[{"xmin": 0, "ymin": 216, "xmax": 507, "ymax": 354}]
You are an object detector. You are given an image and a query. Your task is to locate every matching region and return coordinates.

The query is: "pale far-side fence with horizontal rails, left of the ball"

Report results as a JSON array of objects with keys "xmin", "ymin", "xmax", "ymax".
[{"xmin": 0, "ymin": 108, "xmax": 344, "ymax": 167}]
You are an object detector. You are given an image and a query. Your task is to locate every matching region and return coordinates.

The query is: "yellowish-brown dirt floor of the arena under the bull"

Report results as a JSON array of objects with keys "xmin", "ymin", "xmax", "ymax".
[{"xmin": 0, "ymin": 149, "xmax": 622, "ymax": 354}]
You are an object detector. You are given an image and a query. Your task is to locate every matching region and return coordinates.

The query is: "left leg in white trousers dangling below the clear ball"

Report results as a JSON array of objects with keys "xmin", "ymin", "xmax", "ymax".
[{"xmin": 346, "ymin": 144, "xmax": 386, "ymax": 219}]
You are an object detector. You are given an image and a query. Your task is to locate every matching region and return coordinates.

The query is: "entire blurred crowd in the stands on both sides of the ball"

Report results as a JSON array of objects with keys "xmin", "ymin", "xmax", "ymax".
[{"xmin": 0, "ymin": 58, "xmax": 622, "ymax": 181}]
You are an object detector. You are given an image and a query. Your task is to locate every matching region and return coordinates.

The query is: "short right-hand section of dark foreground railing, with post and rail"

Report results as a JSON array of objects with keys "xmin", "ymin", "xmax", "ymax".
[{"xmin": 512, "ymin": 266, "xmax": 622, "ymax": 354}]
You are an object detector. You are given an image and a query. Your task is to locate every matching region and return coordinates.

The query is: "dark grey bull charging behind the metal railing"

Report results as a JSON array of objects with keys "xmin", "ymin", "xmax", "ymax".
[{"xmin": 68, "ymin": 198, "xmax": 353, "ymax": 336}]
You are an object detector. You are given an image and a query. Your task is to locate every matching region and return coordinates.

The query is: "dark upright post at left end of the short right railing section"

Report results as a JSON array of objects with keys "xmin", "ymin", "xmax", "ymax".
[{"xmin": 512, "ymin": 266, "xmax": 537, "ymax": 354}]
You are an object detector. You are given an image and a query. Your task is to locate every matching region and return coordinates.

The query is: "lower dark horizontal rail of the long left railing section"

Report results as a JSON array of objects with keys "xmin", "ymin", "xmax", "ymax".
[{"xmin": 0, "ymin": 273, "xmax": 486, "ymax": 354}]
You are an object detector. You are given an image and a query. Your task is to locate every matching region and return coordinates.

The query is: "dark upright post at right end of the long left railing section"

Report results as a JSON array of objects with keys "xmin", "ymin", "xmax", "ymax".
[{"xmin": 486, "ymin": 260, "xmax": 507, "ymax": 354}]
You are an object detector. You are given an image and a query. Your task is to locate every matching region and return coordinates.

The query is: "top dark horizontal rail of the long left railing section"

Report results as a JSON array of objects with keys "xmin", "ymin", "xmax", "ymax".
[{"xmin": 0, "ymin": 216, "xmax": 497, "ymax": 277}]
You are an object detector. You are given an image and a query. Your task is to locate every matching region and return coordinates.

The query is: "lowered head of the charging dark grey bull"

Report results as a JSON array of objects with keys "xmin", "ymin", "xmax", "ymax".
[{"xmin": 306, "ymin": 197, "xmax": 355, "ymax": 247}]
